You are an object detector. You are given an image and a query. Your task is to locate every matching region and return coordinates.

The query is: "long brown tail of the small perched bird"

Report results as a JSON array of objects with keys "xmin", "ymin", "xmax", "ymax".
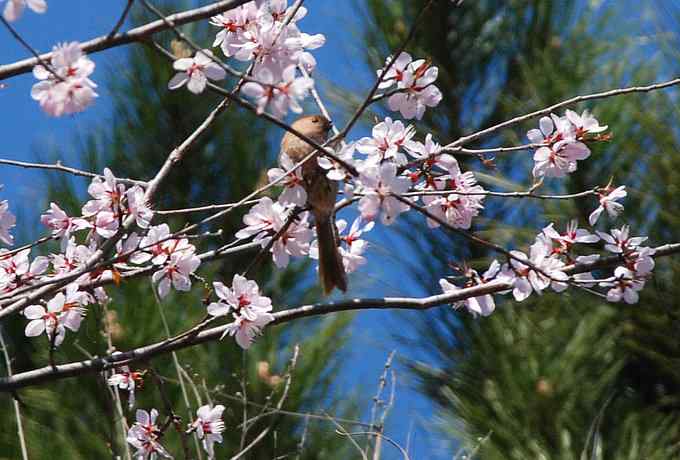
[{"xmin": 316, "ymin": 216, "xmax": 347, "ymax": 294}]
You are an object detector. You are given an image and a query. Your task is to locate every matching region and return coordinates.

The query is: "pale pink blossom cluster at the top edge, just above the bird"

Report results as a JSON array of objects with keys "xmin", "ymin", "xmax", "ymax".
[{"xmin": 168, "ymin": 0, "xmax": 326, "ymax": 117}]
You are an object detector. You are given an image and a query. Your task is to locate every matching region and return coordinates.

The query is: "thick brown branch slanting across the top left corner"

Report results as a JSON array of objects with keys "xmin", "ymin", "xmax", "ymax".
[{"xmin": 0, "ymin": 0, "xmax": 250, "ymax": 81}]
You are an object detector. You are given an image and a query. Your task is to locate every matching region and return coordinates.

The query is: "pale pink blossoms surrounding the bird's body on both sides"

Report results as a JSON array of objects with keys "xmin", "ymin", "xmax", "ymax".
[{"xmin": 236, "ymin": 113, "xmax": 485, "ymax": 273}]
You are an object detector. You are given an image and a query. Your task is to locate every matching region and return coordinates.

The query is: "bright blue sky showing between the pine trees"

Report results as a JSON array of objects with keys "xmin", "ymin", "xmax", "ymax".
[{"xmin": 0, "ymin": 0, "xmax": 451, "ymax": 459}]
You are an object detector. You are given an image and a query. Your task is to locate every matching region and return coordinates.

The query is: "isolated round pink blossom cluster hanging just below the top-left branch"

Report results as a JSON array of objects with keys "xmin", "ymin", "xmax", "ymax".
[{"xmin": 31, "ymin": 42, "xmax": 98, "ymax": 117}]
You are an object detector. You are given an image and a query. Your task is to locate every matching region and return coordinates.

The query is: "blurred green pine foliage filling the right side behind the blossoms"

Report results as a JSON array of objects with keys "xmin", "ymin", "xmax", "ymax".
[{"xmin": 367, "ymin": 0, "xmax": 680, "ymax": 459}]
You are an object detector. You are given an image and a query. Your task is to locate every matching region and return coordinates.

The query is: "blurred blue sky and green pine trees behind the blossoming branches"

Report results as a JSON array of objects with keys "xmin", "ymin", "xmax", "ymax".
[{"xmin": 0, "ymin": 0, "xmax": 680, "ymax": 460}]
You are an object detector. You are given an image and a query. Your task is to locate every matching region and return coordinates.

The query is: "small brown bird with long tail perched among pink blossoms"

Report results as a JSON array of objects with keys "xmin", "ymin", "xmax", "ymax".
[{"xmin": 279, "ymin": 115, "xmax": 347, "ymax": 294}]
